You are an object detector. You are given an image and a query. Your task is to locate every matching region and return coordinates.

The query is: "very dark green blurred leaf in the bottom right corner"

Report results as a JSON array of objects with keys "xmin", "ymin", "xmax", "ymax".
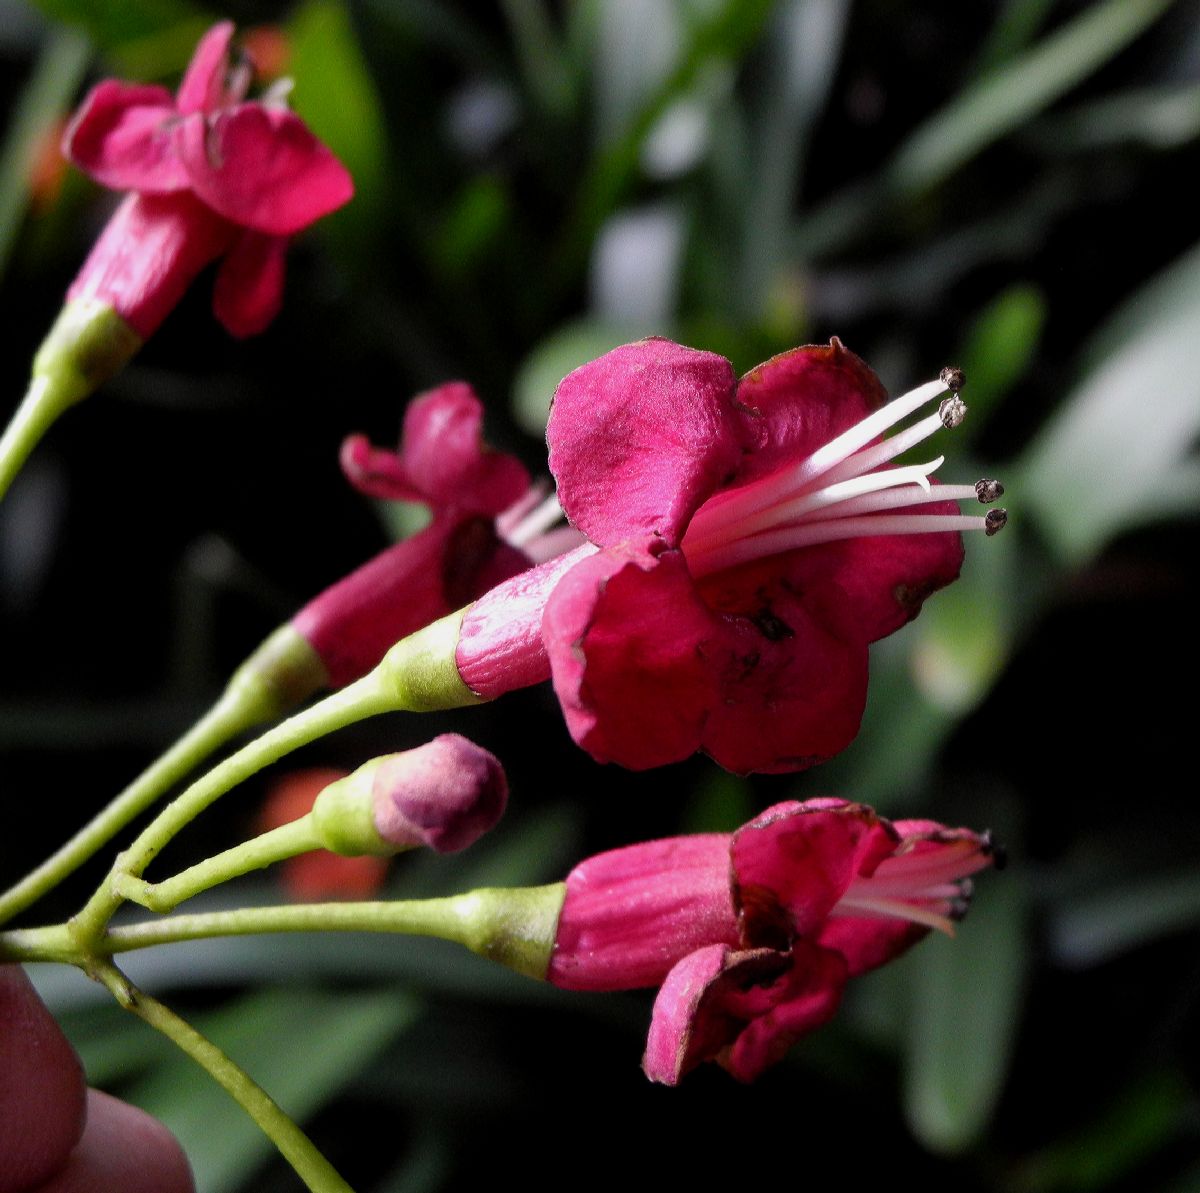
[{"xmin": 1016, "ymin": 1073, "xmax": 1192, "ymax": 1193}]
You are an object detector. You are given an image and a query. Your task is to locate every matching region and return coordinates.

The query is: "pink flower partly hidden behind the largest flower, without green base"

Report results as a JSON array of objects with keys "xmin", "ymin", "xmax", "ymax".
[{"xmin": 292, "ymin": 382, "xmax": 556, "ymax": 688}]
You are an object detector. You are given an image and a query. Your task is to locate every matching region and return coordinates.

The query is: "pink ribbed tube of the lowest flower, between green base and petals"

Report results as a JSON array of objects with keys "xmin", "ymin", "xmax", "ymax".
[{"xmin": 546, "ymin": 833, "xmax": 737, "ymax": 990}]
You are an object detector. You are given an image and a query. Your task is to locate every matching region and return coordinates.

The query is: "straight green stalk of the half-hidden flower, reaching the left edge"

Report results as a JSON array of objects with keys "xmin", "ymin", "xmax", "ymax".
[{"xmin": 0, "ymin": 689, "xmax": 258, "ymax": 924}]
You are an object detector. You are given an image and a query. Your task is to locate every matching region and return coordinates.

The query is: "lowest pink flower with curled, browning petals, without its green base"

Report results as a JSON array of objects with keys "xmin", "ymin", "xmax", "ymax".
[{"xmin": 547, "ymin": 799, "xmax": 995, "ymax": 1085}]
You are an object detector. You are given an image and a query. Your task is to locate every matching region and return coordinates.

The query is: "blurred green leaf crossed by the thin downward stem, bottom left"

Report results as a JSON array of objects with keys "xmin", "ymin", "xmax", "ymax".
[{"xmin": 125, "ymin": 990, "xmax": 420, "ymax": 1193}]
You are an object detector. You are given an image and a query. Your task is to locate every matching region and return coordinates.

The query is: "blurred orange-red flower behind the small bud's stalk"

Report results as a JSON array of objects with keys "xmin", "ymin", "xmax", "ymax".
[{"xmin": 257, "ymin": 767, "xmax": 388, "ymax": 903}]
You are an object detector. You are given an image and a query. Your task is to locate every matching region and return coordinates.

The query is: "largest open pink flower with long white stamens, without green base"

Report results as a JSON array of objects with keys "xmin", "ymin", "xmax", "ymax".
[{"xmin": 456, "ymin": 340, "xmax": 1006, "ymax": 772}]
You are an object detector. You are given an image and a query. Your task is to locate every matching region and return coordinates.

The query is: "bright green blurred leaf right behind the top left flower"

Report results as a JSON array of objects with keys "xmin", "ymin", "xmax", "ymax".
[{"xmin": 289, "ymin": 0, "xmax": 388, "ymax": 254}]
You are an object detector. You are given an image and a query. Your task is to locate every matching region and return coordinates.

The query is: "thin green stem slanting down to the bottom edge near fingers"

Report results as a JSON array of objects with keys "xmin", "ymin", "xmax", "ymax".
[{"xmin": 95, "ymin": 963, "xmax": 354, "ymax": 1193}]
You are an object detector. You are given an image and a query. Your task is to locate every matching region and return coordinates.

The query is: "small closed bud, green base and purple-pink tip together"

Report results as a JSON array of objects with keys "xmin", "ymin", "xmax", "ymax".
[{"xmin": 312, "ymin": 733, "xmax": 509, "ymax": 856}]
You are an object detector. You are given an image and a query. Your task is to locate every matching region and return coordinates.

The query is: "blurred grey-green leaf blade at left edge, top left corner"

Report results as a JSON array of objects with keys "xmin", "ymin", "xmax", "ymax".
[{"xmin": 0, "ymin": 30, "xmax": 90, "ymax": 275}]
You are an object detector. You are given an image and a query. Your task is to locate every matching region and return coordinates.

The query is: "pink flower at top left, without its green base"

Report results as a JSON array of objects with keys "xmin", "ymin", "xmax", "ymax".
[{"xmin": 62, "ymin": 22, "xmax": 354, "ymax": 338}]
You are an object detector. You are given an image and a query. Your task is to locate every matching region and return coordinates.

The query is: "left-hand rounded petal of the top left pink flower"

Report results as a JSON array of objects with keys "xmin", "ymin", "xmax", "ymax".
[{"xmin": 62, "ymin": 79, "xmax": 190, "ymax": 194}]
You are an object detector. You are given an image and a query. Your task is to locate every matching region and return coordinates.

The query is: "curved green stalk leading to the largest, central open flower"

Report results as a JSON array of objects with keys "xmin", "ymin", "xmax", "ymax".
[{"xmin": 71, "ymin": 671, "xmax": 402, "ymax": 946}]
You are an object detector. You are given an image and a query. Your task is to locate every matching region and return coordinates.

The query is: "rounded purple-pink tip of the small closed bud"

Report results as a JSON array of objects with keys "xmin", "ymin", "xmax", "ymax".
[{"xmin": 372, "ymin": 733, "xmax": 509, "ymax": 853}]
